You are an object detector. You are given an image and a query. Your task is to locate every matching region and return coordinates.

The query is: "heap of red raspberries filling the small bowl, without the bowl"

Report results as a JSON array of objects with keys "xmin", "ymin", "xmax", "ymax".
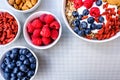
[{"xmin": 27, "ymin": 14, "xmax": 60, "ymax": 46}]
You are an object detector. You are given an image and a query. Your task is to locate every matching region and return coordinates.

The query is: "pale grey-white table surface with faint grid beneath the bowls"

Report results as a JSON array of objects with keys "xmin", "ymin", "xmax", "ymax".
[{"xmin": 0, "ymin": 0, "xmax": 120, "ymax": 80}]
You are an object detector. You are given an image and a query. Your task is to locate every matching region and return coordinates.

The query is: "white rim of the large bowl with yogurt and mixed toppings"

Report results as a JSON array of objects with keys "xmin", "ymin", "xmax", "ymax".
[{"xmin": 62, "ymin": 0, "xmax": 120, "ymax": 43}]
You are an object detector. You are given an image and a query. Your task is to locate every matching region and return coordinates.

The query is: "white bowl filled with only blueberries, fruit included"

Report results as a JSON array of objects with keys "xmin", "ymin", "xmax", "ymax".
[{"xmin": 0, "ymin": 46, "xmax": 38, "ymax": 80}]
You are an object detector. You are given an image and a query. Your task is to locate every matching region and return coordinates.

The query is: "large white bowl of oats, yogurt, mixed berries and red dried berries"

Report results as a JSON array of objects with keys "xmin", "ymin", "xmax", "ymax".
[{"xmin": 62, "ymin": 0, "xmax": 120, "ymax": 43}]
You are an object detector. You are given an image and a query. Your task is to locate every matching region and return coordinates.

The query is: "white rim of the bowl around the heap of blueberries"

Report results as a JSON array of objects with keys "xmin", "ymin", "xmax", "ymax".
[{"xmin": 0, "ymin": 46, "xmax": 38, "ymax": 80}]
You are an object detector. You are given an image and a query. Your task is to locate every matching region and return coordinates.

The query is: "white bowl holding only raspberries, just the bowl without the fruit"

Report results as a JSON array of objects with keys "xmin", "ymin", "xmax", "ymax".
[{"xmin": 23, "ymin": 11, "xmax": 62, "ymax": 49}]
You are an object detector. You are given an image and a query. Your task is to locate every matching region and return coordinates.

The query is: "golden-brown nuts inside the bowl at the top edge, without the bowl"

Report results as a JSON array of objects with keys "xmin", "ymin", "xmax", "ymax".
[{"xmin": 8, "ymin": 0, "xmax": 38, "ymax": 10}]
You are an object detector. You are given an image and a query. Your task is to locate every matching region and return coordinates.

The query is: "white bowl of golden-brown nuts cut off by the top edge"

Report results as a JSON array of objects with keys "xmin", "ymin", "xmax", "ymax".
[{"xmin": 5, "ymin": 0, "xmax": 41, "ymax": 13}]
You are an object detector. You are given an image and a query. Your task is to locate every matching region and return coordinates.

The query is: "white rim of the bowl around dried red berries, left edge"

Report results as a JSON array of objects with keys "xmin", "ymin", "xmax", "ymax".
[{"xmin": 0, "ymin": 9, "xmax": 21, "ymax": 47}]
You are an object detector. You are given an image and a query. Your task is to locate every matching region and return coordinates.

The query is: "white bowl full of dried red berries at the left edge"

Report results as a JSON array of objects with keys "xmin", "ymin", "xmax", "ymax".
[{"xmin": 0, "ymin": 9, "xmax": 21, "ymax": 47}]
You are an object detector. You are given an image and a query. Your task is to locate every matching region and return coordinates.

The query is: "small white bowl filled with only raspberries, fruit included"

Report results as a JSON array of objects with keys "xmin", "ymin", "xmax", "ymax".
[{"xmin": 23, "ymin": 11, "xmax": 62, "ymax": 49}]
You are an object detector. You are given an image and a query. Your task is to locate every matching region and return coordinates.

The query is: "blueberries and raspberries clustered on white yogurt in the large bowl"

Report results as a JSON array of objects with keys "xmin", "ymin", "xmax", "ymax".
[{"xmin": 72, "ymin": 0, "xmax": 107, "ymax": 37}]
